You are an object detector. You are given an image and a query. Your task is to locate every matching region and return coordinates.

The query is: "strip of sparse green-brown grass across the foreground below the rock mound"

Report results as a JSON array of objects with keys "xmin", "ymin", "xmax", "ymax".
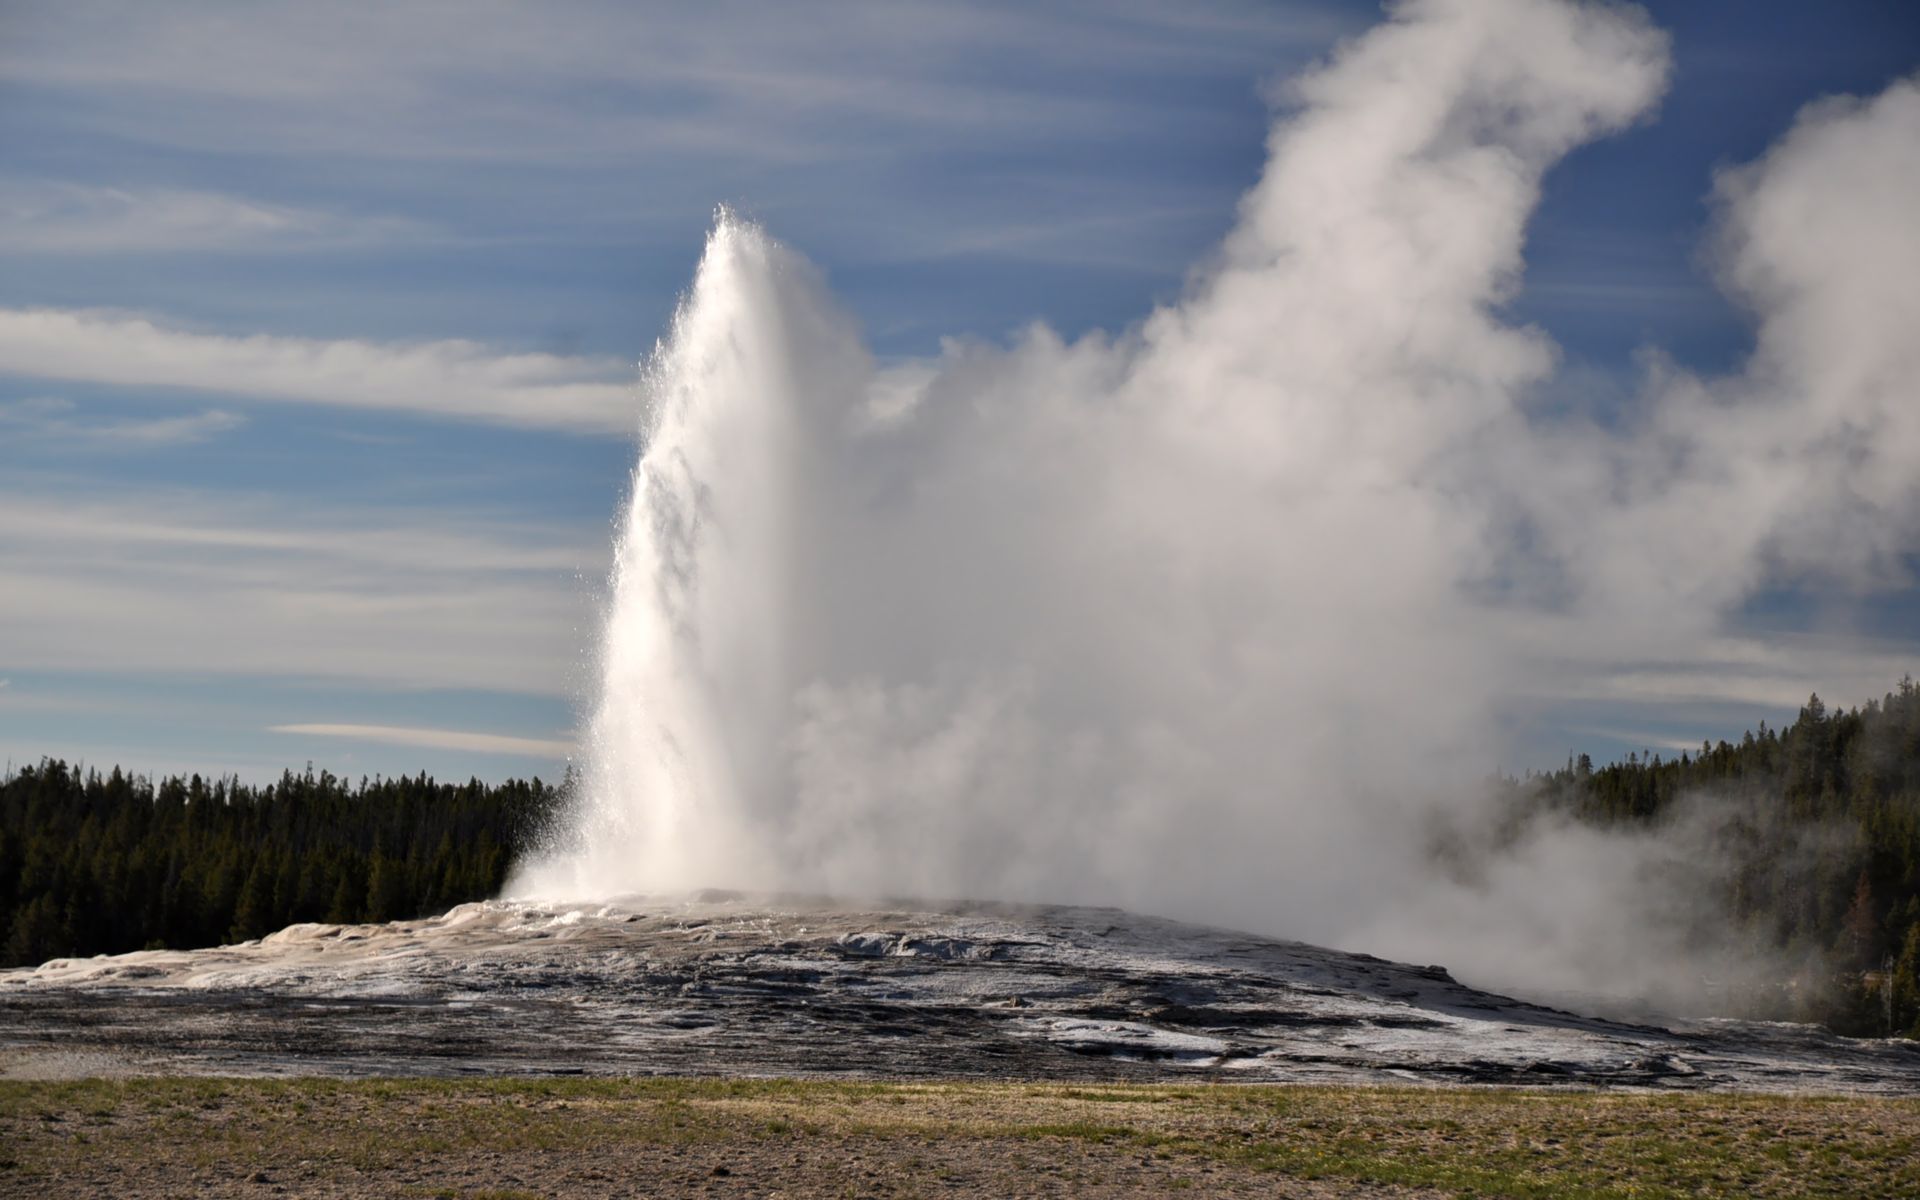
[{"xmin": 0, "ymin": 1077, "xmax": 1920, "ymax": 1200}]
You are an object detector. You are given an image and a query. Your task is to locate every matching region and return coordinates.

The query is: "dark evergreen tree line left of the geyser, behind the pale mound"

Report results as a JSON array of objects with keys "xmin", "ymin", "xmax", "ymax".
[{"xmin": 0, "ymin": 758, "xmax": 561, "ymax": 966}]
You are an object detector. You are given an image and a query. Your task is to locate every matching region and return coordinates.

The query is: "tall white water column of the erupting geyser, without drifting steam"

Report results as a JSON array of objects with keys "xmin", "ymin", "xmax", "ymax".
[{"xmin": 520, "ymin": 219, "xmax": 831, "ymax": 895}]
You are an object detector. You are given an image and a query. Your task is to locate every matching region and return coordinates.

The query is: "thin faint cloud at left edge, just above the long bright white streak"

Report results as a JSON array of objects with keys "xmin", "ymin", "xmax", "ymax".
[{"xmin": 0, "ymin": 180, "xmax": 426, "ymax": 253}]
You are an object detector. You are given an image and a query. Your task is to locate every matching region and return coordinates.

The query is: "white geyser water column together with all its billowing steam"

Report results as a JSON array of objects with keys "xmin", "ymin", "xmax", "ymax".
[{"xmin": 515, "ymin": 0, "xmax": 1920, "ymax": 989}]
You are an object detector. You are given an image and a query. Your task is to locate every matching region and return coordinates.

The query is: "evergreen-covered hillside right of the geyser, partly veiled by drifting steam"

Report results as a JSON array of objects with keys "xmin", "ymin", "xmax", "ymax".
[{"xmin": 1505, "ymin": 678, "xmax": 1920, "ymax": 1037}]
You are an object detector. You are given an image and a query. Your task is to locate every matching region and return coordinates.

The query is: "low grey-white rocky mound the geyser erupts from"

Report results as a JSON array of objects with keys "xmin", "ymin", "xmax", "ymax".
[{"xmin": 0, "ymin": 893, "xmax": 1920, "ymax": 1094}]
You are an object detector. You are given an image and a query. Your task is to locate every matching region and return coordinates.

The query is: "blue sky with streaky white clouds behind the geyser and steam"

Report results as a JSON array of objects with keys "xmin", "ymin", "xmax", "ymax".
[{"xmin": 0, "ymin": 0, "xmax": 1920, "ymax": 778}]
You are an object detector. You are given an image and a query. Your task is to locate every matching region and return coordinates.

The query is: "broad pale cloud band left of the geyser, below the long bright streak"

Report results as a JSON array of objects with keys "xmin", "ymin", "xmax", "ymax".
[{"xmin": 0, "ymin": 488, "xmax": 607, "ymax": 697}]
